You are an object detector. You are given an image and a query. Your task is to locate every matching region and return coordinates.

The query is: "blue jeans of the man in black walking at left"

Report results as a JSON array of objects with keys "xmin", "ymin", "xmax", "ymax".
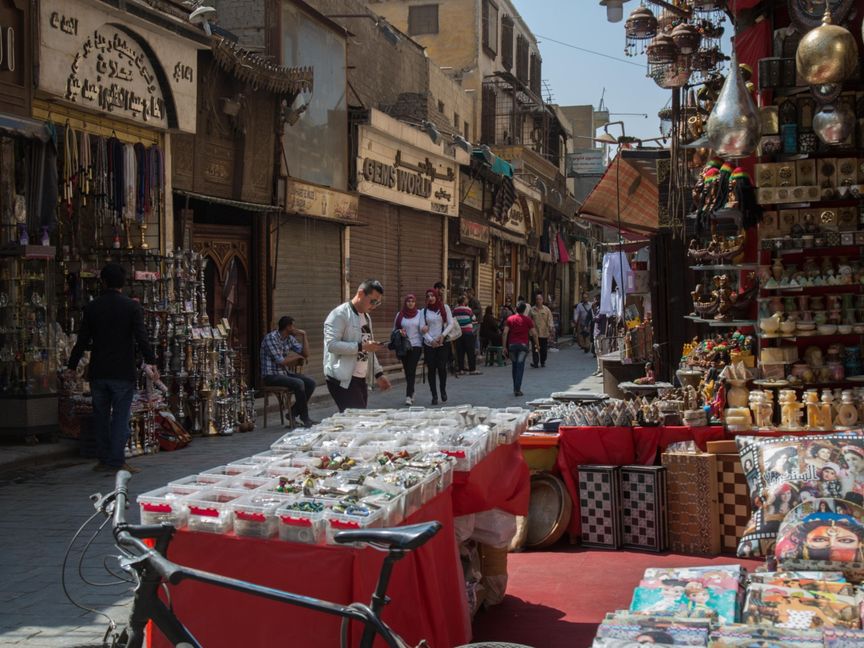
[{"xmin": 90, "ymin": 378, "xmax": 135, "ymax": 468}]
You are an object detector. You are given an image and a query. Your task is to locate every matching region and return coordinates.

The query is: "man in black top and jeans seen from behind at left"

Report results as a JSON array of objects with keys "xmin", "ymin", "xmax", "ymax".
[{"xmin": 68, "ymin": 263, "xmax": 159, "ymax": 472}]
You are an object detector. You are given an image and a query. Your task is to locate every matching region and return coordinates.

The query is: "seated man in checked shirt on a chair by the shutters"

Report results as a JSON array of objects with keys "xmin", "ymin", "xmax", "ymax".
[{"xmin": 261, "ymin": 315, "xmax": 316, "ymax": 427}]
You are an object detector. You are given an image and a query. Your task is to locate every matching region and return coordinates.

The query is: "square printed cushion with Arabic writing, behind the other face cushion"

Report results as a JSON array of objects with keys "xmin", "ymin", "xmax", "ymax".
[{"xmin": 736, "ymin": 431, "xmax": 864, "ymax": 558}]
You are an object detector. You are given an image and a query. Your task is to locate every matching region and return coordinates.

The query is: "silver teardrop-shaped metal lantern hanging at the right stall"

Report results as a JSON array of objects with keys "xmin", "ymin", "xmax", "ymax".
[{"xmin": 705, "ymin": 53, "xmax": 759, "ymax": 158}]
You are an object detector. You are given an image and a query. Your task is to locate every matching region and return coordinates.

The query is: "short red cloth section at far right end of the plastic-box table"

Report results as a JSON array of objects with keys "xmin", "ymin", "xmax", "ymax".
[{"xmin": 453, "ymin": 443, "xmax": 531, "ymax": 516}]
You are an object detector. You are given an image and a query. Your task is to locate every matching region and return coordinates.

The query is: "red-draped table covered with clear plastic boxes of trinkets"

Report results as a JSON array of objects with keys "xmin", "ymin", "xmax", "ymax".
[{"xmin": 138, "ymin": 406, "xmax": 529, "ymax": 648}]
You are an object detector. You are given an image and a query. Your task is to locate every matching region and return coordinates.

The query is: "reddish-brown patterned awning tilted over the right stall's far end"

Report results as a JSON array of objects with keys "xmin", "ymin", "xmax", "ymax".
[{"xmin": 578, "ymin": 151, "xmax": 668, "ymax": 235}]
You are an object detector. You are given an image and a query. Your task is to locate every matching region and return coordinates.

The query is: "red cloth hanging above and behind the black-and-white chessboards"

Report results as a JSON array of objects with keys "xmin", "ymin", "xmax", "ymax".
[{"xmin": 558, "ymin": 426, "xmax": 727, "ymax": 541}]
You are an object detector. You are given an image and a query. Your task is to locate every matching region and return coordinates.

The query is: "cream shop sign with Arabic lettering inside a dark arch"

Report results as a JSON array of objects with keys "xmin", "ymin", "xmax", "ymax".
[{"xmin": 39, "ymin": 0, "xmax": 197, "ymax": 132}]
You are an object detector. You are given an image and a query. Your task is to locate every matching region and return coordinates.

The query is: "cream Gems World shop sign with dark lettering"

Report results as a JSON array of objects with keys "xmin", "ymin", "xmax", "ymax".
[{"xmin": 357, "ymin": 127, "xmax": 459, "ymax": 216}]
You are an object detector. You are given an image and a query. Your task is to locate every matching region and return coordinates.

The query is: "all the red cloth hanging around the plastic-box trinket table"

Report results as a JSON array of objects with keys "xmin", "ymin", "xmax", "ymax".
[{"xmin": 151, "ymin": 443, "xmax": 530, "ymax": 648}]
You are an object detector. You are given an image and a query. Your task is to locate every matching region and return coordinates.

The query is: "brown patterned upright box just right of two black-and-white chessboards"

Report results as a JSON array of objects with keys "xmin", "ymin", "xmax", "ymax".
[{"xmin": 661, "ymin": 452, "xmax": 720, "ymax": 556}]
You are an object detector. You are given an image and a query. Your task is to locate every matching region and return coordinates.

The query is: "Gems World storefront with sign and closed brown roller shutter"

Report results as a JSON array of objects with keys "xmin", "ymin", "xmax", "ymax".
[{"xmin": 349, "ymin": 110, "xmax": 467, "ymax": 364}]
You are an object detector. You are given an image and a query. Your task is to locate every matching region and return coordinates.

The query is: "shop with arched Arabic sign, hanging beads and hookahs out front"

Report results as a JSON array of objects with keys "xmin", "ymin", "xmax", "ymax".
[{"xmin": 34, "ymin": 1, "xmax": 253, "ymax": 455}]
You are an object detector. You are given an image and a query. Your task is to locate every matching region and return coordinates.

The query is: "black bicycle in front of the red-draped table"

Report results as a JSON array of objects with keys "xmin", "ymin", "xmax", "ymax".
[{"xmin": 71, "ymin": 470, "xmax": 530, "ymax": 648}]
